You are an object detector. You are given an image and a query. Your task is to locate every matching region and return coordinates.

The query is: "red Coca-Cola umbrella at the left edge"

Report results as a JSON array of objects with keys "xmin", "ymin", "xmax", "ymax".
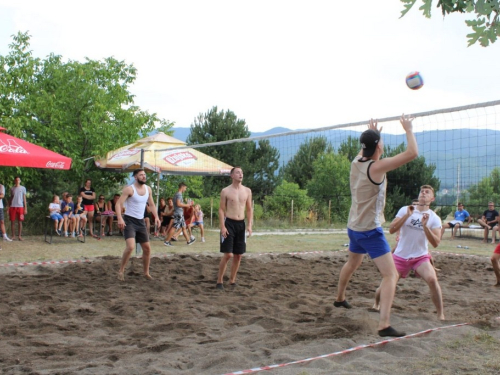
[{"xmin": 0, "ymin": 127, "xmax": 71, "ymax": 170}]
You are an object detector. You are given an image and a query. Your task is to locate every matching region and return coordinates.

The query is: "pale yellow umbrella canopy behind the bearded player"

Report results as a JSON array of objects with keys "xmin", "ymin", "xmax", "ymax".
[{"xmin": 95, "ymin": 132, "xmax": 232, "ymax": 176}]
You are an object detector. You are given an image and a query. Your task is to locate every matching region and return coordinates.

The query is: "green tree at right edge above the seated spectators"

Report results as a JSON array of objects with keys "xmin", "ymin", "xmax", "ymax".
[{"xmin": 464, "ymin": 167, "xmax": 500, "ymax": 214}]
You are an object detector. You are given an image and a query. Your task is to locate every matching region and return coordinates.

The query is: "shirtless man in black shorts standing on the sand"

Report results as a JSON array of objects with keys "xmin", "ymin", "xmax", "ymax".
[{"xmin": 216, "ymin": 167, "xmax": 253, "ymax": 290}]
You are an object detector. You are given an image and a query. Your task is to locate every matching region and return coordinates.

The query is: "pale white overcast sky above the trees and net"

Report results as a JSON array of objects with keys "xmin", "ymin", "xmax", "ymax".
[{"xmin": 0, "ymin": 0, "xmax": 500, "ymax": 132}]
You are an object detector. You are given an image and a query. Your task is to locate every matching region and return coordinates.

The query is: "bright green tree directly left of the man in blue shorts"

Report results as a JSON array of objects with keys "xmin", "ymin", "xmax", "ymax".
[{"xmin": 307, "ymin": 152, "xmax": 351, "ymax": 220}]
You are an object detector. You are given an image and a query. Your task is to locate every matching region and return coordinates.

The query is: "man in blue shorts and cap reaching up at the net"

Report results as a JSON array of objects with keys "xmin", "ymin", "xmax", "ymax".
[{"xmin": 334, "ymin": 115, "xmax": 418, "ymax": 337}]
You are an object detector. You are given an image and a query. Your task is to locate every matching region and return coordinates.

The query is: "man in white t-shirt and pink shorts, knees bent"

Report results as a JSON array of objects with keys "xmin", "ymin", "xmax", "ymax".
[{"xmin": 373, "ymin": 185, "xmax": 444, "ymax": 320}]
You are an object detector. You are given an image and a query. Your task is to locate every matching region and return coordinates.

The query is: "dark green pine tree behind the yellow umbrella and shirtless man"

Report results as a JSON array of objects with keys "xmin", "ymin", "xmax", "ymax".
[{"xmin": 187, "ymin": 107, "xmax": 279, "ymax": 201}]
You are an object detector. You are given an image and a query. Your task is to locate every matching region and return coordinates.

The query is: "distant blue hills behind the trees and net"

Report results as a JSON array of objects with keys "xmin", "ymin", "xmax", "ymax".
[{"xmin": 173, "ymin": 127, "xmax": 500, "ymax": 189}]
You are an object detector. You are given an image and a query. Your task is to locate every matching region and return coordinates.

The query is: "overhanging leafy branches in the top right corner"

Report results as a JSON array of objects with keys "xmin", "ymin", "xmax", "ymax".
[{"xmin": 401, "ymin": 0, "xmax": 500, "ymax": 47}]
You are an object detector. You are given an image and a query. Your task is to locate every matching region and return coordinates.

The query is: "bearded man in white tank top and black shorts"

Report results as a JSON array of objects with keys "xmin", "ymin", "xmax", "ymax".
[{"xmin": 115, "ymin": 169, "xmax": 161, "ymax": 281}]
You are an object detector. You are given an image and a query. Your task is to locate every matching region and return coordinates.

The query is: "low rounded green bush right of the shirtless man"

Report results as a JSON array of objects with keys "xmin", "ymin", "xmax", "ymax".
[{"xmin": 264, "ymin": 180, "xmax": 314, "ymax": 219}]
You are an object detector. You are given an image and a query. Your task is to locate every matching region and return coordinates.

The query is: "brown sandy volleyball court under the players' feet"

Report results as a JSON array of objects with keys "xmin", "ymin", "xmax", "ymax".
[{"xmin": 0, "ymin": 252, "xmax": 500, "ymax": 375}]
